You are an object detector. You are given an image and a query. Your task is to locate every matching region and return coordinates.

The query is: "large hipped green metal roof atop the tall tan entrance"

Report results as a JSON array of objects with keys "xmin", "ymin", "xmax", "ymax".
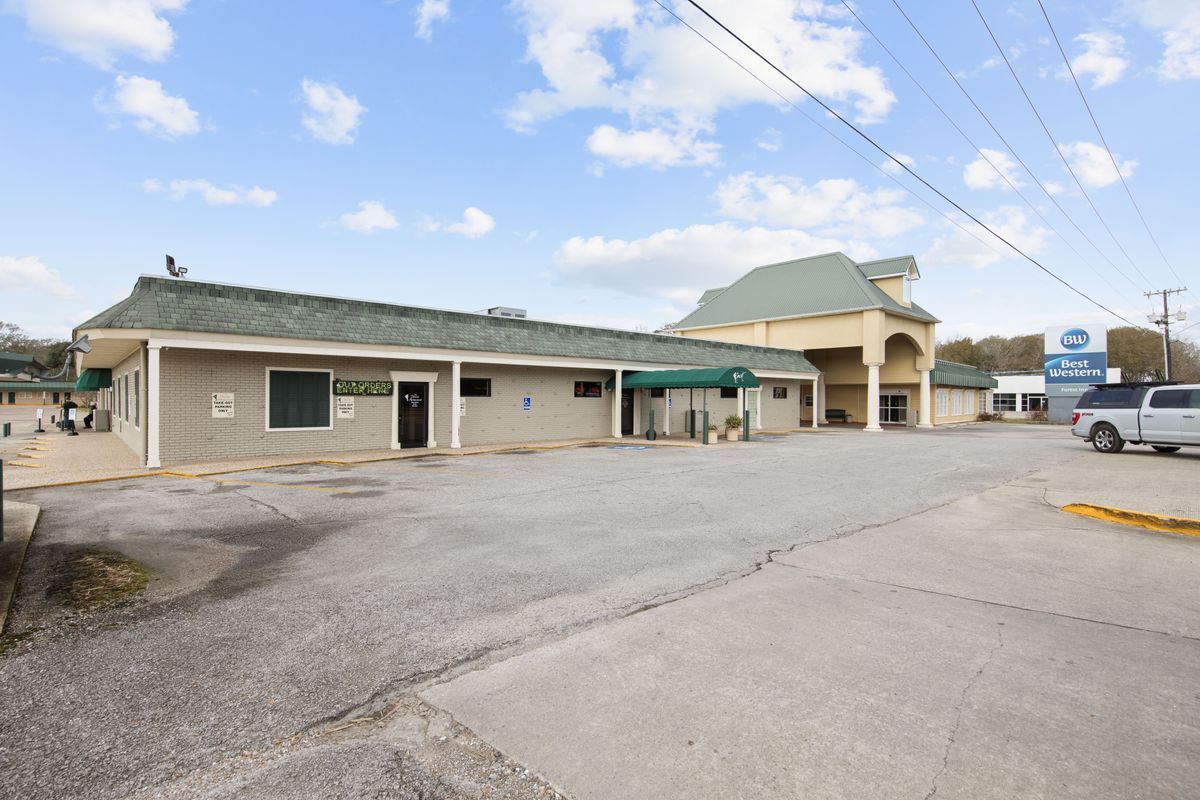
[{"xmin": 676, "ymin": 253, "xmax": 937, "ymax": 329}]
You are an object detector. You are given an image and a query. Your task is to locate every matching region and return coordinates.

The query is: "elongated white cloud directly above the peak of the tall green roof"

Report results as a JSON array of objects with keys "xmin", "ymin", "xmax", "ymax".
[{"xmin": 716, "ymin": 173, "xmax": 924, "ymax": 239}]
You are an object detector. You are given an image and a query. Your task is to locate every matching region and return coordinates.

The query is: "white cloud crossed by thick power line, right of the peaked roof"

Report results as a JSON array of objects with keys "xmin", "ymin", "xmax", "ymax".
[{"xmin": 918, "ymin": 205, "xmax": 1051, "ymax": 270}]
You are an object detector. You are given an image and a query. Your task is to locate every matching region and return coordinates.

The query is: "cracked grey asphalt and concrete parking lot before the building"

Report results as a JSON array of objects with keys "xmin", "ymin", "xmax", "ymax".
[{"xmin": 0, "ymin": 425, "xmax": 1200, "ymax": 798}]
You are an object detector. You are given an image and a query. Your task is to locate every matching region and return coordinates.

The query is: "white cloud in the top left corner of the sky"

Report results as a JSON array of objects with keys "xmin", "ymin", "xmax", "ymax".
[{"xmin": 5, "ymin": 0, "xmax": 187, "ymax": 70}]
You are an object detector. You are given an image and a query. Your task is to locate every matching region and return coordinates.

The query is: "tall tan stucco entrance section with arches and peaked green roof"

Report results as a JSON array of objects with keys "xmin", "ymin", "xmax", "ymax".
[{"xmin": 674, "ymin": 253, "xmax": 996, "ymax": 431}]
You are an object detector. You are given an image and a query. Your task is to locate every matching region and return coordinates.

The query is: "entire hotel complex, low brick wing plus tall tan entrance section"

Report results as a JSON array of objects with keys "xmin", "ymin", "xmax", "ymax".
[{"xmin": 76, "ymin": 253, "xmax": 992, "ymax": 468}]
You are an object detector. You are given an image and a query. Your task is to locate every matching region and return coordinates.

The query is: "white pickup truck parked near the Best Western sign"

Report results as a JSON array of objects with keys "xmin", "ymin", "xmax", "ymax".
[{"xmin": 1070, "ymin": 384, "xmax": 1200, "ymax": 453}]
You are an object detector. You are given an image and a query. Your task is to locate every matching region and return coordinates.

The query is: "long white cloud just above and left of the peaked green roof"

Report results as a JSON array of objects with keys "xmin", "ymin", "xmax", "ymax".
[{"xmin": 554, "ymin": 222, "xmax": 878, "ymax": 315}]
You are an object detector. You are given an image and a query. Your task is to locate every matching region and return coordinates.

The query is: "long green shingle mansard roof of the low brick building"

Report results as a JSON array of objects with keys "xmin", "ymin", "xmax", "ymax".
[{"xmin": 77, "ymin": 276, "xmax": 818, "ymax": 373}]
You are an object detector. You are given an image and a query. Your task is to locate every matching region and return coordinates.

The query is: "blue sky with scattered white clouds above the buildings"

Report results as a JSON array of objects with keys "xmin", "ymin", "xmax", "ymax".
[{"xmin": 0, "ymin": 0, "xmax": 1200, "ymax": 341}]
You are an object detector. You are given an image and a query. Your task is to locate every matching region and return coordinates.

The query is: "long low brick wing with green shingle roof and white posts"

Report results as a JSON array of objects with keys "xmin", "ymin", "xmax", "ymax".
[{"xmin": 76, "ymin": 276, "xmax": 820, "ymax": 467}]
